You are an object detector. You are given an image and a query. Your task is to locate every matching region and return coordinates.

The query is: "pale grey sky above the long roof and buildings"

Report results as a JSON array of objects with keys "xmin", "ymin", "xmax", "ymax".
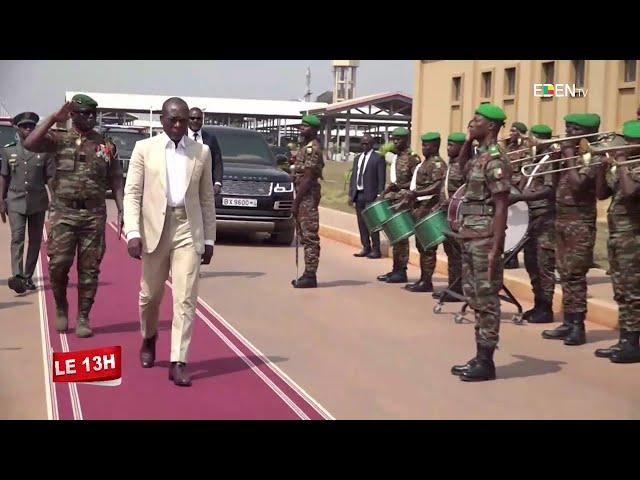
[{"xmin": 0, "ymin": 60, "xmax": 414, "ymax": 117}]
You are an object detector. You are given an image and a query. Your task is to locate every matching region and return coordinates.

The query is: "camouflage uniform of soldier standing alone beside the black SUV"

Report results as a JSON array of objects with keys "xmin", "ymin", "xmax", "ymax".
[{"xmin": 293, "ymin": 138, "xmax": 324, "ymax": 275}]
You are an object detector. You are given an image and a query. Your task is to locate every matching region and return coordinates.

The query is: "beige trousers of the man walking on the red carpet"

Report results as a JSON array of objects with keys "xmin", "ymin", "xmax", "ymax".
[{"xmin": 139, "ymin": 207, "xmax": 201, "ymax": 363}]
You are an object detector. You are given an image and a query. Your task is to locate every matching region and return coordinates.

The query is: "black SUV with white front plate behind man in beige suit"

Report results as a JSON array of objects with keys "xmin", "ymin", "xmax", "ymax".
[{"xmin": 202, "ymin": 125, "xmax": 295, "ymax": 245}]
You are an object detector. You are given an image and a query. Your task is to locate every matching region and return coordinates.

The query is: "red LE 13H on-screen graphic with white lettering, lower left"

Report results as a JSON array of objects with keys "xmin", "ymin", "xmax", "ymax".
[{"xmin": 53, "ymin": 346, "xmax": 122, "ymax": 386}]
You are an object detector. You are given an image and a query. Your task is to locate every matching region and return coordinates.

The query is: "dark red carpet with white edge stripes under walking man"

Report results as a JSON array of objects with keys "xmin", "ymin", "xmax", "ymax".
[{"xmin": 40, "ymin": 225, "xmax": 326, "ymax": 419}]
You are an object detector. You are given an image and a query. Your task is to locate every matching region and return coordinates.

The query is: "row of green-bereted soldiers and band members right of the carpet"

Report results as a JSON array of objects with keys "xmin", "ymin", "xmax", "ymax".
[{"xmin": 292, "ymin": 104, "xmax": 640, "ymax": 381}]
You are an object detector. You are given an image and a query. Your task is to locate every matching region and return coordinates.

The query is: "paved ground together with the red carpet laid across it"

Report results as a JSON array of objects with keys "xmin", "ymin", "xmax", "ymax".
[{"xmin": 0, "ymin": 206, "xmax": 640, "ymax": 419}]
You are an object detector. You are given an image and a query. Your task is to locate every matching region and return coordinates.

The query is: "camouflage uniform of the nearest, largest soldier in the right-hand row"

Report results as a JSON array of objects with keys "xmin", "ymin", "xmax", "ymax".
[{"xmin": 460, "ymin": 145, "xmax": 511, "ymax": 347}]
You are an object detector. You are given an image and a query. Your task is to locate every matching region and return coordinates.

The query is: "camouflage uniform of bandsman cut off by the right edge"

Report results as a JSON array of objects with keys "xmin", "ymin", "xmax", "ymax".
[{"xmin": 606, "ymin": 163, "xmax": 640, "ymax": 332}]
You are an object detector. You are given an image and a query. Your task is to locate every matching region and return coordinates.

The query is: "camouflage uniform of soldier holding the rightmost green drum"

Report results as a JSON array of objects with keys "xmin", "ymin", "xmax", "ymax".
[{"xmin": 411, "ymin": 155, "xmax": 446, "ymax": 281}]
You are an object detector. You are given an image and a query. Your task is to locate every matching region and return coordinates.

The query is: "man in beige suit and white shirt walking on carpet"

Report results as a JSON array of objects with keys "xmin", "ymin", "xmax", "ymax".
[{"xmin": 124, "ymin": 98, "xmax": 216, "ymax": 387}]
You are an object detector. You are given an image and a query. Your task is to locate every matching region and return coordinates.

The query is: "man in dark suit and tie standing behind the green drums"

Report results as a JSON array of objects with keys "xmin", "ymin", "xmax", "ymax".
[{"xmin": 349, "ymin": 134, "xmax": 386, "ymax": 258}]
